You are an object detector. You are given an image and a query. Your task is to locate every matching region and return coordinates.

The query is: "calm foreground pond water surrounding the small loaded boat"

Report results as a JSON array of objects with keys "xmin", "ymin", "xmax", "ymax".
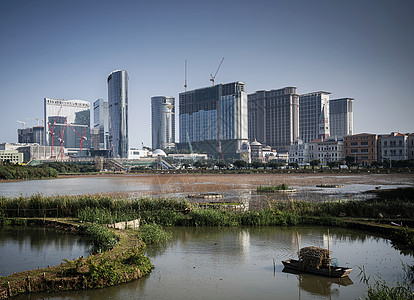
[{"xmin": 14, "ymin": 227, "xmax": 413, "ymax": 300}]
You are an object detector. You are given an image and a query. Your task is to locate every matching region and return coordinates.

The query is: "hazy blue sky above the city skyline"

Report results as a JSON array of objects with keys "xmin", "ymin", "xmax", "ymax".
[{"xmin": 0, "ymin": 0, "xmax": 414, "ymax": 147}]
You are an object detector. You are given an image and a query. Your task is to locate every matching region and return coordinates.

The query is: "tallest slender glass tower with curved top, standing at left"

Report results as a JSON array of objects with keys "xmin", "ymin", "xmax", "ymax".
[{"xmin": 108, "ymin": 70, "xmax": 129, "ymax": 158}]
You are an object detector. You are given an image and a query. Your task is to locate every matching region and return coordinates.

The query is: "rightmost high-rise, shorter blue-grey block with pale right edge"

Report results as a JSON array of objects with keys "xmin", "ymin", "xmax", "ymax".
[{"xmin": 329, "ymin": 98, "xmax": 354, "ymax": 137}]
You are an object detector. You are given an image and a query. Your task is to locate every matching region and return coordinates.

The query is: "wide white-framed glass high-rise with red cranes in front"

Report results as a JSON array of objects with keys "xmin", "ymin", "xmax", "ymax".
[{"xmin": 44, "ymin": 98, "xmax": 91, "ymax": 155}]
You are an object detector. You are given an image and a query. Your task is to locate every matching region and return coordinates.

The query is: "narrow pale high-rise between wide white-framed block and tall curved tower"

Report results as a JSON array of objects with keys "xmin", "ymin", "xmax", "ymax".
[{"xmin": 93, "ymin": 99, "xmax": 109, "ymax": 150}]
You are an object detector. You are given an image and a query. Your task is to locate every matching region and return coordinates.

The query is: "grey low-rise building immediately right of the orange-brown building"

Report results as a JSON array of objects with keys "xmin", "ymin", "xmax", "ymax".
[{"xmin": 381, "ymin": 132, "xmax": 408, "ymax": 161}]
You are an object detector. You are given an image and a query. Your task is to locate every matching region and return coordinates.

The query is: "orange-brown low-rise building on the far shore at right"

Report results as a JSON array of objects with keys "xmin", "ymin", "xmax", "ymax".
[{"xmin": 344, "ymin": 133, "xmax": 378, "ymax": 166}]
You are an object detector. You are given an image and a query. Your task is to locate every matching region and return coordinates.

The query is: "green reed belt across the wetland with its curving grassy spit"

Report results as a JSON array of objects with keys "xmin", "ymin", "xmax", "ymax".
[{"xmin": 0, "ymin": 188, "xmax": 414, "ymax": 299}]
